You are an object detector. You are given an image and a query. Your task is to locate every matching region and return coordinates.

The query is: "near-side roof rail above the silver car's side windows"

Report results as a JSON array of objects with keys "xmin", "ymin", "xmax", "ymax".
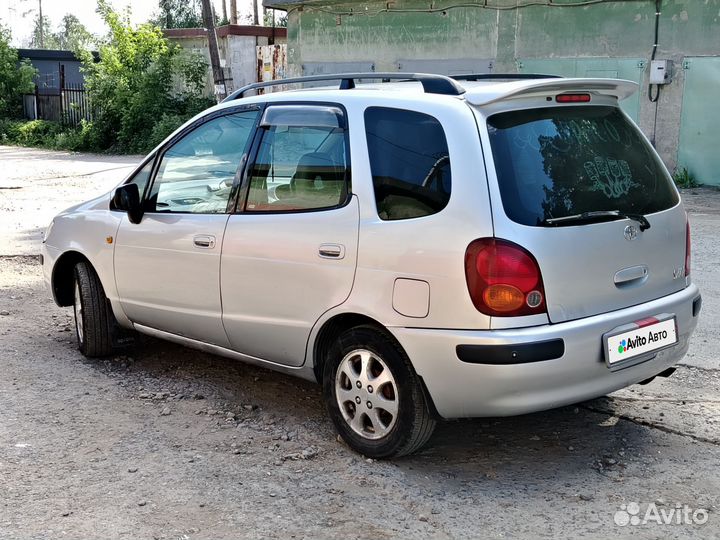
[{"xmin": 222, "ymin": 72, "xmax": 465, "ymax": 103}]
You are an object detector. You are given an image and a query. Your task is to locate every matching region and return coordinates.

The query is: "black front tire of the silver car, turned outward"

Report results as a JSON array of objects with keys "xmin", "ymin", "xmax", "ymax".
[{"xmin": 73, "ymin": 262, "xmax": 114, "ymax": 358}]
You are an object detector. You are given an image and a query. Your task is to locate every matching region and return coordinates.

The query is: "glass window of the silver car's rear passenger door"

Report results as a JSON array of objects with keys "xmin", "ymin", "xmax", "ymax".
[{"xmin": 245, "ymin": 125, "xmax": 348, "ymax": 212}]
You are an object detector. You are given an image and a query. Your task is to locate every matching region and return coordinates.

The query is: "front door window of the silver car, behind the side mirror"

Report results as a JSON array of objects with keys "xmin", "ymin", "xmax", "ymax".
[{"xmin": 145, "ymin": 110, "xmax": 259, "ymax": 214}]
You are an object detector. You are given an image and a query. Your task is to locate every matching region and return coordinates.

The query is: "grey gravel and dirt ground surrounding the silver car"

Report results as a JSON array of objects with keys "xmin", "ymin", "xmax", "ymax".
[{"xmin": 0, "ymin": 147, "xmax": 720, "ymax": 539}]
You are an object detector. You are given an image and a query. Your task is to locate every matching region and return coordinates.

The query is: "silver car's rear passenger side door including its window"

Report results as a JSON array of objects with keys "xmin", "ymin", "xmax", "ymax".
[{"xmin": 220, "ymin": 105, "xmax": 359, "ymax": 366}]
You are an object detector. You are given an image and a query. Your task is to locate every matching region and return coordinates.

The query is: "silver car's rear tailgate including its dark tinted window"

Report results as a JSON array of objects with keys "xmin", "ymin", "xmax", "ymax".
[{"xmin": 478, "ymin": 99, "xmax": 686, "ymax": 322}]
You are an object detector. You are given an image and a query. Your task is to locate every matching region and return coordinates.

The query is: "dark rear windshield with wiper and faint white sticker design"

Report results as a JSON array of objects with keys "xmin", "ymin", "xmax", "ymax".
[{"xmin": 487, "ymin": 106, "xmax": 679, "ymax": 226}]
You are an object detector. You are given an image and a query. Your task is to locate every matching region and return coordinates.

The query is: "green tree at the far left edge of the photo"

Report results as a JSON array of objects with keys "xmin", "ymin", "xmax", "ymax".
[{"xmin": 0, "ymin": 25, "xmax": 37, "ymax": 119}]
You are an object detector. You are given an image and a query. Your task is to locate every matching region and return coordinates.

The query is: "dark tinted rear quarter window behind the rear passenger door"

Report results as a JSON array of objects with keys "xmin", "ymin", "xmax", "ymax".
[{"xmin": 365, "ymin": 107, "xmax": 451, "ymax": 220}]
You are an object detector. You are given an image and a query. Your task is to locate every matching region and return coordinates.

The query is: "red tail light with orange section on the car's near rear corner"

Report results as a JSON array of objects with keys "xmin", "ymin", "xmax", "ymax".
[{"xmin": 465, "ymin": 238, "xmax": 546, "ymax": 317}]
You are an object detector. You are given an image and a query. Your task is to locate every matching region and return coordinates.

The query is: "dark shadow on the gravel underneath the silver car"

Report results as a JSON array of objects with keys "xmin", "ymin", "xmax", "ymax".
[{"xmin": 87, "ymin": 336, "xmax": 656, "ymax": 483}]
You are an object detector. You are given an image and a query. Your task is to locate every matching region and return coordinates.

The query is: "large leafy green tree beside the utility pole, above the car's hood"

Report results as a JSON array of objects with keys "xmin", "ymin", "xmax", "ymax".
[{"xmin": 78, "ymin": 0, "xmax": 213, "ymax": 152}]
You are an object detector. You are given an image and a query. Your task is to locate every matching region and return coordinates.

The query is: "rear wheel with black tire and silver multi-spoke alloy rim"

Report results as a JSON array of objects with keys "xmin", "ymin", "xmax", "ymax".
[{"xmin": 323, "ymin": 326, "xmax": 436, "ymax": 458}]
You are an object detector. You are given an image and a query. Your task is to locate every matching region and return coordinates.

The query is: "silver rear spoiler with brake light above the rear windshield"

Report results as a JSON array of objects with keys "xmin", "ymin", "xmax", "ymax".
[{"xmin": 465, "ymin": 79, "xmax": 638, "ymax": 105}]
